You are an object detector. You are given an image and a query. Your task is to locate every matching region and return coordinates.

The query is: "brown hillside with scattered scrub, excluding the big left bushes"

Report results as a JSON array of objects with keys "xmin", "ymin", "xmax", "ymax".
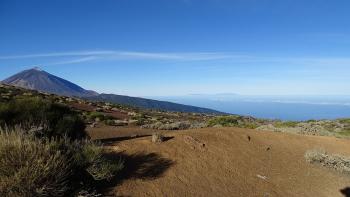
[{"xmin": 0, "ymin": 82, "xmax": 350, "ymax": 197}]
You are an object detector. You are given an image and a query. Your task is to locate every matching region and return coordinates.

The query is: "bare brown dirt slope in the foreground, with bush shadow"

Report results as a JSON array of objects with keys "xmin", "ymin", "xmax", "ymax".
[{"xmin": 106, "ymin": 128, "xmax": 350, "ymax": 197}]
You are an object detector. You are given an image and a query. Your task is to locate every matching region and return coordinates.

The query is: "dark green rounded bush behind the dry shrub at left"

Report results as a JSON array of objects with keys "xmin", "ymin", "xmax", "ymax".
[{"xmin": 0, "ymin": 97, "xmax": 87, "ymax": 139}]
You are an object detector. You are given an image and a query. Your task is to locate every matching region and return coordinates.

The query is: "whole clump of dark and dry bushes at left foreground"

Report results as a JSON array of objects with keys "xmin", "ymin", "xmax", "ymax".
[{"xmin": 0, "ymin": 90, "xmax": 123, "ymax": 197}]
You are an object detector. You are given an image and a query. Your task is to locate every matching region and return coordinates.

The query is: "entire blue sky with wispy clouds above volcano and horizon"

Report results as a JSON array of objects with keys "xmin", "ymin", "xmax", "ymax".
[{"xmin": 0, "ymin": 0, "xmax": 350, "ymax": 96}]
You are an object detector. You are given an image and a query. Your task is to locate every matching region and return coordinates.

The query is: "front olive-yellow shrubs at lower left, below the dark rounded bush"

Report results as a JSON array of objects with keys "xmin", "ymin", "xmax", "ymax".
[{"xmin": 0, "ymin": 128, "xmax": 123, "ymax": 196}]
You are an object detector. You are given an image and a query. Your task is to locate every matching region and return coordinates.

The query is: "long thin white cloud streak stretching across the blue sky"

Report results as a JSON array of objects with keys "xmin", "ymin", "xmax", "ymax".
[{"xmin": 0, "ymin": 50, "xmax": 350, "ymax": 66}]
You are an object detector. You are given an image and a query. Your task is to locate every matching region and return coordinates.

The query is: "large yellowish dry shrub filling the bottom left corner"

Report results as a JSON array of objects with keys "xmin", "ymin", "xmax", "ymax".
[{"xmin": 0, "ymin": 131, "xmax": 72, "ymax": 196}]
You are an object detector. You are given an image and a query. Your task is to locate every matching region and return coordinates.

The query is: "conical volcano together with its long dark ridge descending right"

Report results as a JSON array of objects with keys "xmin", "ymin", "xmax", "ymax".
[{"xmin": 2, "ymin": 68, "xmax": 222, "ymax": 114}]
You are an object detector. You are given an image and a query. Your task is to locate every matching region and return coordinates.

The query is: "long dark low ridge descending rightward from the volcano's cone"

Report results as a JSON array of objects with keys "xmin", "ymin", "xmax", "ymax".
[{"xmin": 88, "ymin": 94, "xmax": 223, "ymax": 114}]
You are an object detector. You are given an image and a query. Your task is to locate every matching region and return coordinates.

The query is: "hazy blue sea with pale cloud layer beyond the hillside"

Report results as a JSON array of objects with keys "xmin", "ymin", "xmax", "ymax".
[{"xmin": 153, "ymin": 94, "xmax": 350, "ymax": 120}]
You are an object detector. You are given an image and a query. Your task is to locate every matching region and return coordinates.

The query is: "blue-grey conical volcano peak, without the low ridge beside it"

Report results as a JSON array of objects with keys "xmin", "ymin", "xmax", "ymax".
[{"xmin": 2, "ymin": 68, "xmax": 98, "ymax": 97}]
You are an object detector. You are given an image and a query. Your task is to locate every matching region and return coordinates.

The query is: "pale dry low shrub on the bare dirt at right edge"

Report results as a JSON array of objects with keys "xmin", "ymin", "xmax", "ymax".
[{"xmin": 305, "ymin": 149, "xmax": 350, "ymax": 173}]
